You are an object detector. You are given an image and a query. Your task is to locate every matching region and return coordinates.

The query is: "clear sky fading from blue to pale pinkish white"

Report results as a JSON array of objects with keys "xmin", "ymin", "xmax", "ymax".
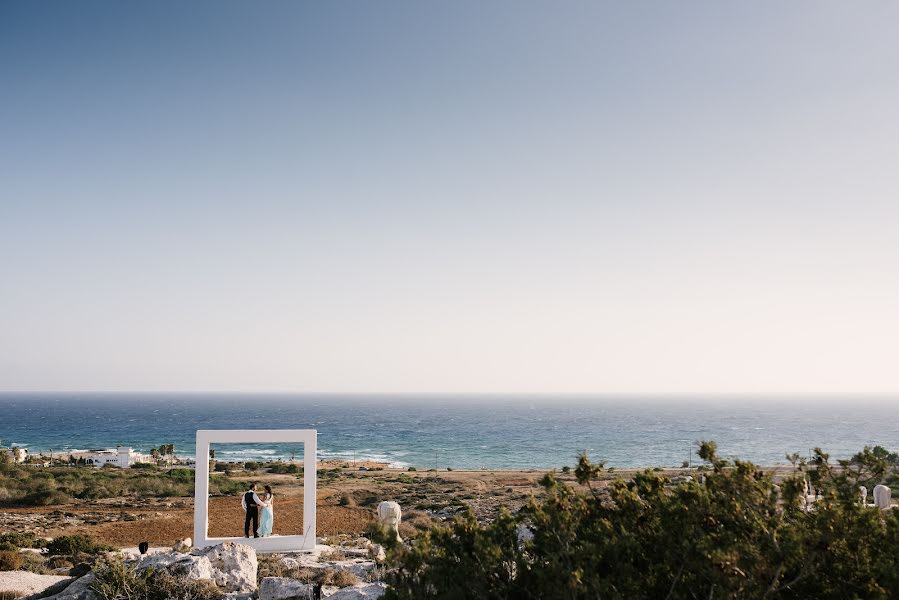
[{"xmin": 0, "ymin": 0, "xmax": 899, "ymax": 394}]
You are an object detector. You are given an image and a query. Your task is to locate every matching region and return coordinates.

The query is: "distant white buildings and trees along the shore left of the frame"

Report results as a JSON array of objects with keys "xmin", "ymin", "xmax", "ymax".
[{"xmin": 0, "ymin": 444, "xmax": 195, "ymax": 469}]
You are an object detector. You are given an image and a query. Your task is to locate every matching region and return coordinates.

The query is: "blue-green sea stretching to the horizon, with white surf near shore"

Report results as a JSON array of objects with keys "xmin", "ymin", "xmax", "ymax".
[{"xmin": 0, "ymin": 393, "xmax": 899, "ymax": 469}]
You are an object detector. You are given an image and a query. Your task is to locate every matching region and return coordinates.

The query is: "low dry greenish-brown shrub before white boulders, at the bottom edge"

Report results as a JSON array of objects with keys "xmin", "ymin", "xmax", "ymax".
[{"xmin": 90, "ymin": 558, "xmax": 223, "ymax": 600}]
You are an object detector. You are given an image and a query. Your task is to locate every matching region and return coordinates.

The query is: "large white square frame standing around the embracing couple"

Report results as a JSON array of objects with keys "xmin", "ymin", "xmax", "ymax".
[{"xmin": 194, "ymin": 429, "xmax": 318, "ymax": 552}]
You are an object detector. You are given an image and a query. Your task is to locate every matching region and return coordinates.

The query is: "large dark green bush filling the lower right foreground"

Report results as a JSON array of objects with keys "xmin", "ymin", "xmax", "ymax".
[{"xmin": 384, "ymin": 442, "xmax": 899, "ymax": 600}]
